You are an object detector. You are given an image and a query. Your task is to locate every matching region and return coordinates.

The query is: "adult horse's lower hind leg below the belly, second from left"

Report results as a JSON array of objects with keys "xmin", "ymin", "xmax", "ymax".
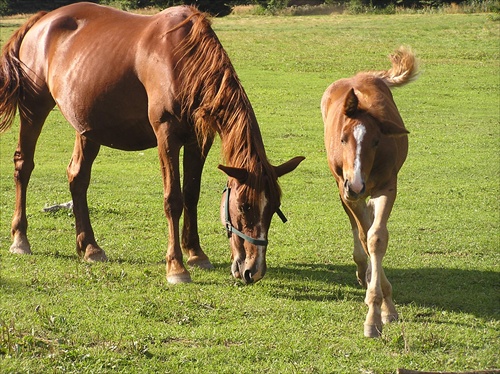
[{"xmin": 67, "ymin": 133, "xmax": 107, "ymax": 262}]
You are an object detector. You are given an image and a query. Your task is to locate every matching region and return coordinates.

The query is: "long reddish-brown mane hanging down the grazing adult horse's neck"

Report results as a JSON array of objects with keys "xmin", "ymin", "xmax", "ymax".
[{"xmin": 172, "ymin": 7, "xmax": 281, "ymax": 201}]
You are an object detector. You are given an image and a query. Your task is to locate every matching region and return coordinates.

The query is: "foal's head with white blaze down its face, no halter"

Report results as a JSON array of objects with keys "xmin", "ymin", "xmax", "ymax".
[{"xmin": 338, "ymin": 89, "xmax": 408, "ymax": 200}]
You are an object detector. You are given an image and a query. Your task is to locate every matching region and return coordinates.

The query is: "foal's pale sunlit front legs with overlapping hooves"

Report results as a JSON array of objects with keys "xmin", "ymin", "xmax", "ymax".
[{"xmin": 364, "ymin": 188, "xmax": 398, "ymax": 337}]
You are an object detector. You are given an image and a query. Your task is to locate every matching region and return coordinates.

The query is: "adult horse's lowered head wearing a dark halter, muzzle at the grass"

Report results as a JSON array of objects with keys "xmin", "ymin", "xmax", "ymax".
[{"xmin": 219, "ymin": 157, "xmax": 304, "ymax": 283}]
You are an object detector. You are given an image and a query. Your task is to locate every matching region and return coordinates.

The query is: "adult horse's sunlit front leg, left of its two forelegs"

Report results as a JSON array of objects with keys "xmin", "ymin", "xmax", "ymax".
[{"xmin": 156, "ymin": 129, "xmax": 191, "ymax": 283}]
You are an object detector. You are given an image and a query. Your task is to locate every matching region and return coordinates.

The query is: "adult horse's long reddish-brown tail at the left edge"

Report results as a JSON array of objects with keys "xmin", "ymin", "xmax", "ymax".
[{"xmin": 0, "ymin": 12, "xmax": 47, "ymax": 134}]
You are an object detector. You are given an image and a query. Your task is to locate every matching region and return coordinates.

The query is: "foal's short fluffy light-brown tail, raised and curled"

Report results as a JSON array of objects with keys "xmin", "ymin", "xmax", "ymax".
[{"xmin": 370, "ymin": 46, "xmax": 419, "ymax": 87}]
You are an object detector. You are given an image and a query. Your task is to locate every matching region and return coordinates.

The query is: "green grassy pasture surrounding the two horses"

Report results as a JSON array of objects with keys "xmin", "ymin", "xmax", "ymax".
[{"xmin": 0, "ymin": 9, "xmax": 500, "ymax": 373}]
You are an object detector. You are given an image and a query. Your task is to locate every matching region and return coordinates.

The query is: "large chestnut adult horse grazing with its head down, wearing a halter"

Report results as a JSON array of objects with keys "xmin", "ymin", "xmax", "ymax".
[{"xmin": 0, "ymin": 3, "xmax": 303, "ymax": 283}]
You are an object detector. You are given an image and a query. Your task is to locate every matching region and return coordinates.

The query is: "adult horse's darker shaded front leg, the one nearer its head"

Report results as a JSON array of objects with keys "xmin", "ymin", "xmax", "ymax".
[{"xmin": 182, "ymin": 139, "xmax": 213, "ymax": 269}]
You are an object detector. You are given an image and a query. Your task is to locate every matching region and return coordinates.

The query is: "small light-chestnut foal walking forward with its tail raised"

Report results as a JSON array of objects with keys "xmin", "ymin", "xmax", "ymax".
[{"xmin": 321, "ymin": 47, "xmax": 418, "ymax": 337}]
